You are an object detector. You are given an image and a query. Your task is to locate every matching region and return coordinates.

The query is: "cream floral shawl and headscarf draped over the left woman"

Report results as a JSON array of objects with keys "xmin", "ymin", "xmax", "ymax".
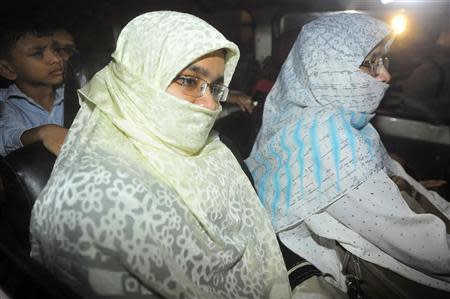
[{"xmin": 31, "ymin": 12, "xmax": 290, "ymax": 298}]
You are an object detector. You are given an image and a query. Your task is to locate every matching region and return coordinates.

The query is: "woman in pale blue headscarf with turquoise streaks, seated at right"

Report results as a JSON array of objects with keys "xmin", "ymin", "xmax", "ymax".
[{"xmin": 246, "ymin": 13, "xmax": 450, "ymax": 298}]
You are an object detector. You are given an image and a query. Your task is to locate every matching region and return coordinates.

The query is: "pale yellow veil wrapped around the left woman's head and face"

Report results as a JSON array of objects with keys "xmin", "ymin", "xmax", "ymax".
[{"xmin": 81, "ymin": 12, "xmax": 239, "ymax": 155}]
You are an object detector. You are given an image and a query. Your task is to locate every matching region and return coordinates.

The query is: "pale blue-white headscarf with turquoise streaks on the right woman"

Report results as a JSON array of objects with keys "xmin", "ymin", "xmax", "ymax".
[{"xmin": 246, "ymin": 14, "xmax": 389, "ymax": 231}]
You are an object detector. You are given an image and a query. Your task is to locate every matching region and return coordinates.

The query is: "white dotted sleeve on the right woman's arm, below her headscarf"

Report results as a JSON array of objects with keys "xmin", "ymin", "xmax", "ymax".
[{"xmin": 327, "ymin": 172, "xmax": 450, "ymax": 275}]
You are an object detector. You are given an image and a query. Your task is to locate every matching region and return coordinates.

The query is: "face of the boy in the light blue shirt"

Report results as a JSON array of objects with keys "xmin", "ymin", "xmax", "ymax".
[{"xmin": 0, "ymin": 33, "xmax": 64, "ymax": 87}]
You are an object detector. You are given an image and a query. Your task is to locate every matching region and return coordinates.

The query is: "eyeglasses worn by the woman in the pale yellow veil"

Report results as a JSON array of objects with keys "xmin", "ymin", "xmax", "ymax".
[{"xmin": 174, "ymin": 75, "xmax": 228, "ymax": 102}]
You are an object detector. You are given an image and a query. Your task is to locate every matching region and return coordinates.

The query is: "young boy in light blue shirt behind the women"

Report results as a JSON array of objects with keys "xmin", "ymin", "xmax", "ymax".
[{"xmin": 0, "ymin": 21, "xmax": 67, "ymax": 155}]
